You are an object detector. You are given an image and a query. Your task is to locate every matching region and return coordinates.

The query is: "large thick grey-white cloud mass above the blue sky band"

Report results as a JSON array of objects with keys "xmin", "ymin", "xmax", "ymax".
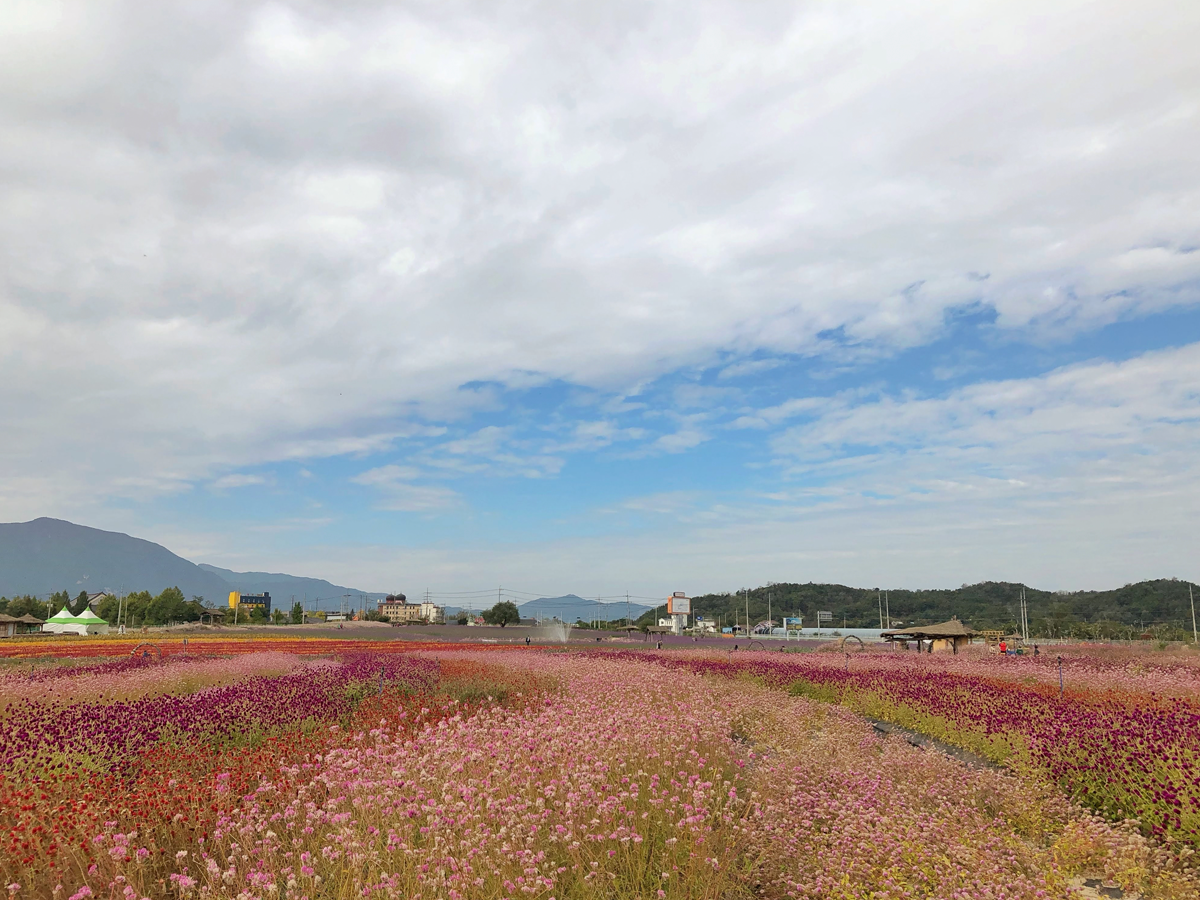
[{"xmin": 0, "ymin": 0, "xmax": 1200, "ymax": 547}]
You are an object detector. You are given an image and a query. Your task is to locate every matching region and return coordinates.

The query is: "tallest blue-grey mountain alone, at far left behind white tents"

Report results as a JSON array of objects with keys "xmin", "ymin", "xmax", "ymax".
[{"xmin": 0, "ymin": 518, "xmax": 229, "ymax": 604}]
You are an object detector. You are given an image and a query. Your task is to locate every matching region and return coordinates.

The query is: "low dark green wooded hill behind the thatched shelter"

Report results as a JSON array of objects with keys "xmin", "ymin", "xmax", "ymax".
[{"xmin": 642, "ymin": 578, "xmax": 1200, "ymax": 636}]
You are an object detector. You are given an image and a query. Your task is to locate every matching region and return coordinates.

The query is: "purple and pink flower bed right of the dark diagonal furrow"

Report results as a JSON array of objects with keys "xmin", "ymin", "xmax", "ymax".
[{"xmin": 583, "ymin": 653, "xmax": 1200, "ymax": 854}]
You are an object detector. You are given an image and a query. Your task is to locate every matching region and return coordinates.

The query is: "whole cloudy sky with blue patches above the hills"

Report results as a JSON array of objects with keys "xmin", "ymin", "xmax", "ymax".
[{"xmin": 0, "ymin": 0, "xmax": 1200, "ymax": 596}]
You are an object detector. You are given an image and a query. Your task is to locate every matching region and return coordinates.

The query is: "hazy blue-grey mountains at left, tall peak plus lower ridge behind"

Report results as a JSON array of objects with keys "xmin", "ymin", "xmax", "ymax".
[{"xmin": 0, "ymin": 518, "xmax": 384, "ymax": 610}]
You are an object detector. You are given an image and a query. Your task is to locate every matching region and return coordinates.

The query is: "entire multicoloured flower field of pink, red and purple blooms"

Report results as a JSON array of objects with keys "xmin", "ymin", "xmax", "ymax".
[{"xmin": 0, "ymin": 641, "xmax": 1200, "ymax": 900}]
